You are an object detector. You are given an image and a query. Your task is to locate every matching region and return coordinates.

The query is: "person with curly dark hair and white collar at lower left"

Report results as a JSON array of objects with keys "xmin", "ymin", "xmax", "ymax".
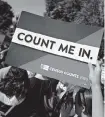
[{"xmin": 0, "ymin": 66, "xmax": 29, "ymax": 115}]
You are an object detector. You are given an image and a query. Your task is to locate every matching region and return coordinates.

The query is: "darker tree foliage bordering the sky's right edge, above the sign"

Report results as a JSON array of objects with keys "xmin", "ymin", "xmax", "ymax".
[{"xmin": 46, "ymin": 0, "xmax": 81, "ymax": 22}]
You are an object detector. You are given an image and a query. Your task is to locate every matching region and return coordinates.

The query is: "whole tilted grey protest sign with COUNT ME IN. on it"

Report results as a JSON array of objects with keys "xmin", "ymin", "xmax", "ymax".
[{"xmin": 5, "ymin": 11, "xmax": 103, "ymax": 88}]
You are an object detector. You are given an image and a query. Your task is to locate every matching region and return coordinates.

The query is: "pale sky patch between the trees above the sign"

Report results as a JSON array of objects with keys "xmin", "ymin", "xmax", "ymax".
[{"xmin": 4, "ymin": 0, "xmax": 45, "ymax": 16}]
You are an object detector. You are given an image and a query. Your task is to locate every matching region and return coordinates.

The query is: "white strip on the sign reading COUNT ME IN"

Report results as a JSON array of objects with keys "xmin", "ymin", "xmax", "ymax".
[{"xmin": 12, "ymin": 28, "xmax": 99, "ymax": 64}]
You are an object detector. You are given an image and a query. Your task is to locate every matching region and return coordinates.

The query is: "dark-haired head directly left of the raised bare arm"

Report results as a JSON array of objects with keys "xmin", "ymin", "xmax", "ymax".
[{"xmin": 76, "ymin": 89, "xmax": 92, "ymax": 117}]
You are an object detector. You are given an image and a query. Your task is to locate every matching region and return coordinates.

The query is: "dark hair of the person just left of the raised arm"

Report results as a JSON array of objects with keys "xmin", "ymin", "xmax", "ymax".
[{"xmin": 76, "ymin": 89, "xmax": 92, "ymax": 117}]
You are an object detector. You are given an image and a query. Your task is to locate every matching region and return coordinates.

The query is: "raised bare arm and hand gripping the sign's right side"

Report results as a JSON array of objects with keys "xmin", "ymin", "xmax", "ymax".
[{"xmin": 89, "ymin": 62, "xmax": 104, "ymax": 117}]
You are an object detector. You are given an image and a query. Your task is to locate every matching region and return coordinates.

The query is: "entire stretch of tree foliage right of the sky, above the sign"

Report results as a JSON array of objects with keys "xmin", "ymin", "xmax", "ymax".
[{"xmin": 45, "ymin": 0, "xmax": 104, "ymax": 27}]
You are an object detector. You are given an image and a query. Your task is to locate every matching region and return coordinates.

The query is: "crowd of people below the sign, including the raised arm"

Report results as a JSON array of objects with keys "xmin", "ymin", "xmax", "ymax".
[{"xmin": 0, "ymin": 36, "xmax": 104, "ymax": 117}]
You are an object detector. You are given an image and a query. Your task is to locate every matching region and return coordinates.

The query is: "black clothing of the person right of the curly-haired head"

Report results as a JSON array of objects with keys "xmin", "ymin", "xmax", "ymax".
[{"xmin": 6, "ymin": 78, "xmax": 58, "ymax": 117}]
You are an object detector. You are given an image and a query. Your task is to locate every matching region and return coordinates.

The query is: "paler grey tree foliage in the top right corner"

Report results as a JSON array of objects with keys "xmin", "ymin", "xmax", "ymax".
[{"xmin": 75, "ymin": 0, "xmax": 104, "ymax": 27}]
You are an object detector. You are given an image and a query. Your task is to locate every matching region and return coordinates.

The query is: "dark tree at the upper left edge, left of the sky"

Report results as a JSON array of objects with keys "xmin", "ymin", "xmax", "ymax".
[{"xmin": 0, "ymin": 0, "xmax": 14, "ymax": 34}]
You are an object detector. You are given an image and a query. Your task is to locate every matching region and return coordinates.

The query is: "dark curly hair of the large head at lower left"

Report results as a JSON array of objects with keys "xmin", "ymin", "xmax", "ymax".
[{"xmin": 0, "ymin": 67, "xmax": 29, "ymax": 100}]
